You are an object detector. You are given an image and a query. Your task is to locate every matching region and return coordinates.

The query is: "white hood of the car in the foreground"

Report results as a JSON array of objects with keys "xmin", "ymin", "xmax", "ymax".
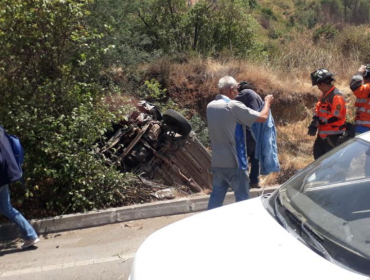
[{"xmin": 131, "ymin": 198, "xmax": 369, "ymax": 280}]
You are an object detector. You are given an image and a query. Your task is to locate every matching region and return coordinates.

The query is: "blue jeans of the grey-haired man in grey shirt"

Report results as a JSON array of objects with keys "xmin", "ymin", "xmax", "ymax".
[{"xmin": 208, "ymin": 168, "xmax": 249, "ymax": 210}]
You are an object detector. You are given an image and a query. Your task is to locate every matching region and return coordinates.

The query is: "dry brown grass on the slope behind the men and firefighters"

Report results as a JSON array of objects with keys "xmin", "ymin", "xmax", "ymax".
[{"xmin": 127, "ymin": 24, "xmax": 370, "ymax": 185}]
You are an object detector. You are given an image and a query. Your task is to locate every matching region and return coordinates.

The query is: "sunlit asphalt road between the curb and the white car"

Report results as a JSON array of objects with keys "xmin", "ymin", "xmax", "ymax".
[{"xmin": 0, "ymin": 214, "xmax": 194, "ymax": 280}]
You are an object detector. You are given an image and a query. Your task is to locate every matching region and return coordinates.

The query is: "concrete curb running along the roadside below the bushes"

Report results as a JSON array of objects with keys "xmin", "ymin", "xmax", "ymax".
[{"xmin": 0, "ymin": 186, "xmax": 278, "ymax": 240}]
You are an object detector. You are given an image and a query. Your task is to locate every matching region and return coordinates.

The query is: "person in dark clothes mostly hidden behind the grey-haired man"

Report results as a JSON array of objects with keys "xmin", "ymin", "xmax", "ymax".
[{"xmin": 235, "ymin": 81, "xmax": 263, "ymax": 188}]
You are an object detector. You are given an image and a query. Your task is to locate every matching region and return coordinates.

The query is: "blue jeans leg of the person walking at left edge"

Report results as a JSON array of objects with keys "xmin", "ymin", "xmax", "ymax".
[{"xmin": 0, "ymin": 185, "xmax": 37, "ymax": 240}]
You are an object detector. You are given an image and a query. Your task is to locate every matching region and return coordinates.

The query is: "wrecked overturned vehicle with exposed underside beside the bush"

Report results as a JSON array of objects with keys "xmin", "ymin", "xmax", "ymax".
[{"xmin": 99, "ymin": 101, "xmax": 211, "ymax": 196}]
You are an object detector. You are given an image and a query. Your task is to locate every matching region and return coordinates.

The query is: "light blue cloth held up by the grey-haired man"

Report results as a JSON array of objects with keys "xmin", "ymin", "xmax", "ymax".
[{"xmin": 251, "ymin": 106, "xmax": 280, "ymax": 175}]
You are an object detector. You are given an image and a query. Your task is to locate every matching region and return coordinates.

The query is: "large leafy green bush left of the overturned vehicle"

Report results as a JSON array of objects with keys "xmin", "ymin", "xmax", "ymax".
[{"xmin": 0, "ymin": 0, "xmax": 138, "ymax": 216}]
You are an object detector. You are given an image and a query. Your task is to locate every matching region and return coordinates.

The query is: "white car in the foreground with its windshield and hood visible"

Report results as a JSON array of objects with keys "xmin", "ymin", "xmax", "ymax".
[{"xmin": 130, "ymin": 132, "xmax": 370, "ymax": 280}]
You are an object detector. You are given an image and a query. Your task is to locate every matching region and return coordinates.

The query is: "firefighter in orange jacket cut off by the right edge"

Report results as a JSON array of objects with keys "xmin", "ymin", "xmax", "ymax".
[{"xmin": 350, "ymin": 64, "xmax": 370, "ymax": 134}]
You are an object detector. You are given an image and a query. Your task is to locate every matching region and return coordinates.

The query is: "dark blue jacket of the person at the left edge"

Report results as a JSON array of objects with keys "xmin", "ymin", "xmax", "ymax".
[{"xmin": 0, "ymin": 126, "xmax": 22, "ymax": 186}]
